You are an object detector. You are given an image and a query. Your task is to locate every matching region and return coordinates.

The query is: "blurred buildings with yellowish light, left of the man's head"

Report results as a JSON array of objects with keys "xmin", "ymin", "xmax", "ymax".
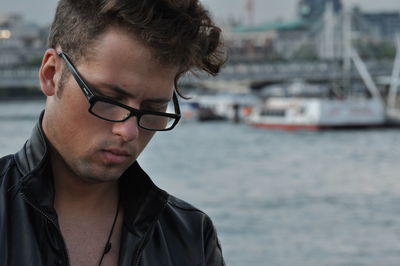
[{"xmin": 0, "ymin": 14, "xmax": 48, "ymax": 66}]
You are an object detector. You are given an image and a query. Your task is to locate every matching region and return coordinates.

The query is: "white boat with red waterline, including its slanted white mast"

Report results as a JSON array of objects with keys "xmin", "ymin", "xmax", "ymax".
[{"xmin": 248, "ymin": 54, "xmax": 386, "ymax": 130}]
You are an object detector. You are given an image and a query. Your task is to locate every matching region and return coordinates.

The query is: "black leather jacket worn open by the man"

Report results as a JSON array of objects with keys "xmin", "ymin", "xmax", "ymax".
[{"xmin": 0, "ymin": 118, "xmax": 225, "ymax": 266}]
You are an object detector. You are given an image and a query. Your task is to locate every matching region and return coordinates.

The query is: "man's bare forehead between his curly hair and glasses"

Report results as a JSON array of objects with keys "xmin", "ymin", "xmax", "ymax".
[{"xmin": 79, "ymin": 27, "xmax": 178, "ymax": 98}]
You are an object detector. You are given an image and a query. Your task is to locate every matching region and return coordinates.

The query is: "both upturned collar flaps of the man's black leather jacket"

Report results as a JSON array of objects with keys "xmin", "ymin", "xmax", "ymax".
[{"xmin": 14, "ymin": 112, "xmax": 168, "ymax": 238}]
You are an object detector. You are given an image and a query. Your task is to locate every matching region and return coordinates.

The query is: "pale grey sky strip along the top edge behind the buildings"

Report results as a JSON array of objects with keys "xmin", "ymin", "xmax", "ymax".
[{"xmin": 0, "ymin": 0, "xmax": 400, "ymax": 25}]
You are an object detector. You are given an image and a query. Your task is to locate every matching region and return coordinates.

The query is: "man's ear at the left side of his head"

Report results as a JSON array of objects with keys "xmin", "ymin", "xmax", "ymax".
[{"xmin": 39, "ymin": 49, "xmax": 62, "ymax": 96}]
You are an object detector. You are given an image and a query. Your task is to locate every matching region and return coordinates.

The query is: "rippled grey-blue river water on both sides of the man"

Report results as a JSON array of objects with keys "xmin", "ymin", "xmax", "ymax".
[{"xmin": 0, "ymin": 102, "xmax": 400, "ymax": 266}]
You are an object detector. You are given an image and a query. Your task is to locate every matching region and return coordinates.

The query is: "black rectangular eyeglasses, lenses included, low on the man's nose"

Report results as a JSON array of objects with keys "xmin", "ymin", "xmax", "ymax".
[{"xmin": 58, "ymin": 52, "xmax": 181, "ymax": 131}]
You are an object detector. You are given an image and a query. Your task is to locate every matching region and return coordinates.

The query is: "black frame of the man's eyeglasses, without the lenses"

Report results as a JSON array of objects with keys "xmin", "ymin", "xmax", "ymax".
[{"xmin": 58, "ymin": 52, "xmax": 181, "ymax": 131}]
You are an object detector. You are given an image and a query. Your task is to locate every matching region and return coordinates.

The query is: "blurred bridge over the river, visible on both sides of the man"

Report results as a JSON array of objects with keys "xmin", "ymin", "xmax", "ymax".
[{"xmin": 0, "ymin": 60, "xmax": 393, "ymax": 91}]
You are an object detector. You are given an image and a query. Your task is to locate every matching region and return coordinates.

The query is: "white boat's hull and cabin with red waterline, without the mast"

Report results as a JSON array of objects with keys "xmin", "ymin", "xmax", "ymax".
[{"xmin": 249, "ymin": 97, "xmax": 385, "ymax": 130}]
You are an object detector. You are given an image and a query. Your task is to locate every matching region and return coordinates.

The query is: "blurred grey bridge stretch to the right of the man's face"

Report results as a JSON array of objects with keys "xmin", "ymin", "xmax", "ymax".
[{"xmin": 183, "ymin": 60, "xmax": 393, "ymax": 92}]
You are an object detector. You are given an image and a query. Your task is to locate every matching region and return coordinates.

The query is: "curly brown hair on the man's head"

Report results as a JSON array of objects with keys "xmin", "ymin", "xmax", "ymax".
[{"xmin": 49, "ymin": 0, "xmax": 226, "ymax": 85}]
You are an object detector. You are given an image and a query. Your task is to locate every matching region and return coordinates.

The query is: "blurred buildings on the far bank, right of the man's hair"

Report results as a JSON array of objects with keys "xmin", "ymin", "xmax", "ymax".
[{"xmin": 224, "ymin": 0, "xmax": 400, "ymax": 61}]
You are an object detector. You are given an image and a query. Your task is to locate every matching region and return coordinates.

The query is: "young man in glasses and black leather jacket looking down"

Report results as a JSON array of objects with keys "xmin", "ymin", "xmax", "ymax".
[{"xmin": 0, "ymin": 0, "xmax": 224, "ymax": 266}]
